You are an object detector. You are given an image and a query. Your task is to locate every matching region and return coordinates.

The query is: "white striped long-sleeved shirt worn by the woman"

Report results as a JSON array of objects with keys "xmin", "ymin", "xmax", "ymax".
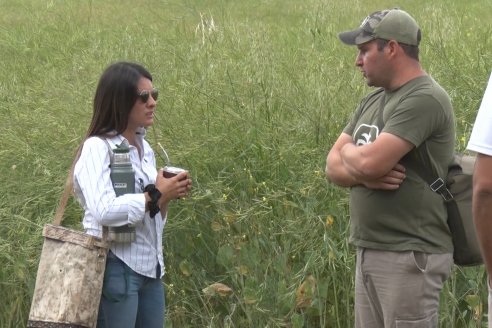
[{"xmin": 73, "ymin": 128, "xmax": 166, "ymax": 278}]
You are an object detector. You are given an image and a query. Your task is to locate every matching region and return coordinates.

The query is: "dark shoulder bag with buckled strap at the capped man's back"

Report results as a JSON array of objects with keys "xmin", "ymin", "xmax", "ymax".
[{"xmin": 414, "ymin": 154, "xmax": 483, "ymax": 266}]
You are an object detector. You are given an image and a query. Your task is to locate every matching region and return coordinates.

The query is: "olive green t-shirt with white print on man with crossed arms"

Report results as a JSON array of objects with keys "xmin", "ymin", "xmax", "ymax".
[{"xmin": 344, "ymin": 76, "xmax": 455, "ymax": 253}]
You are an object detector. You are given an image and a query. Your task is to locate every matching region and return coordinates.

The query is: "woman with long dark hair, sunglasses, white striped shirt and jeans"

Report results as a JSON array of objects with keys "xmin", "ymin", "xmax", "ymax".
[{"xmin": 74, "ymin": 62, "xmax": 191, "ymax": 328}]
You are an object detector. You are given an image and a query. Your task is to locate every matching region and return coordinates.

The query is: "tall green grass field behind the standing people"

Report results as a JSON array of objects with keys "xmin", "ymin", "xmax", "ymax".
[{"xmin": 0, "ymin": 0, "xmax": 492, "ymax": 328}]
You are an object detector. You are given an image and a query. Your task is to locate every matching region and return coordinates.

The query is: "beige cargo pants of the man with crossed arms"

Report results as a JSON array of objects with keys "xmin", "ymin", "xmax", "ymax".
[{"xmin": 355, "ymin": 247, "xmax": 453, "ymax": 328}]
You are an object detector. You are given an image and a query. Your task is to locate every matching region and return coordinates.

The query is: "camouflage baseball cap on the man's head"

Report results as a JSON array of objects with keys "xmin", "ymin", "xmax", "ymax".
[{"xmin": 338, "ymin": 8, "xmax": 421, "ymax": 46}]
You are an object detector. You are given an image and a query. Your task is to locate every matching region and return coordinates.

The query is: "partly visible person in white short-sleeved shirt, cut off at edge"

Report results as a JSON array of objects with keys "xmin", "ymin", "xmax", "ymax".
[{"xmin": 467, "ymin": 74, "xmax": 492, "ymax": 327}]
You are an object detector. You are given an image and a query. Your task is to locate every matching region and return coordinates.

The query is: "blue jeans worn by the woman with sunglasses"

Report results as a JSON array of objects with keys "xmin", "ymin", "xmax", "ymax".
[{"xmin": 97, "ymin": 252, "xmax": 165, "ymax": 328}]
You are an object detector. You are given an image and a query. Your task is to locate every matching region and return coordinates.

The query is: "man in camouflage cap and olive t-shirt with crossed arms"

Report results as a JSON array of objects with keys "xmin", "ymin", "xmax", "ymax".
[{"xmin": 326, "ymin": 9, "xmax": 455, "ymax": 328}]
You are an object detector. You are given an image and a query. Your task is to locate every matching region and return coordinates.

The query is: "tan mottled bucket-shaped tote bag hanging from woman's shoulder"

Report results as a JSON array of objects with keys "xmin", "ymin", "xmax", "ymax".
[{"xmin": 27, "ymin": 166, "xmax": 108, "ymax": 328}]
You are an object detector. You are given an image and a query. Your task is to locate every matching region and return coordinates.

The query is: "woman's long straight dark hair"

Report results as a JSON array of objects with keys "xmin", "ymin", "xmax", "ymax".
[{"xmin": 86, "ymin": 62, "xmax": 152, "ymax": 137}]
